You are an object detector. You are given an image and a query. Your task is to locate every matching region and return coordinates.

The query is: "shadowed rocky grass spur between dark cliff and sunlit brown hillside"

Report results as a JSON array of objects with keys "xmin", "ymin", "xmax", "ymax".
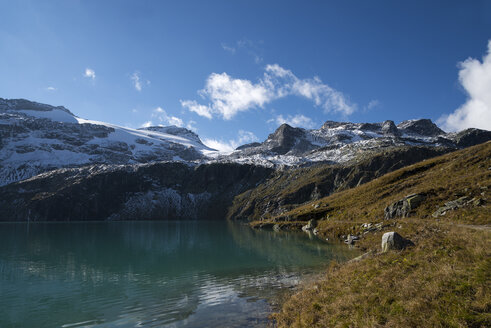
[{"xmin": 228, "ymin": 146, "xmax": 450, "ymax": 220}]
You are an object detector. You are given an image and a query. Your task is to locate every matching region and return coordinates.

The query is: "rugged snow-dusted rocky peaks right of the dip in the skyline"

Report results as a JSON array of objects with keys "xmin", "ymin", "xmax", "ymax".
[{"xmin": 217, "ymin": 119, "xmax": 491, "ymax": 166}]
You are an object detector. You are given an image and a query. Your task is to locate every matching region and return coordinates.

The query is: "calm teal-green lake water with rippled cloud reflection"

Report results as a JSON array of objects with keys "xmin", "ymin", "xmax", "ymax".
[{"xmin": 0, "ymin": 221, "xmax": 357, "ymax": 328}]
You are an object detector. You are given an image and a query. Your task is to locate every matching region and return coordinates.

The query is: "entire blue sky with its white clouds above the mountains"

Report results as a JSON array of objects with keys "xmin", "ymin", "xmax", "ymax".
[{"xmin": 0, "ymin": 0, "xmax": 491, "ymax": 151}]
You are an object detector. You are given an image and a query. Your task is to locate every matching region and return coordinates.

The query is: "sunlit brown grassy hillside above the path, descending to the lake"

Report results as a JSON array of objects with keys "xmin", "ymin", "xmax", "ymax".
[{"xmin": 276, "ymin": 142, "xmax": 491, "ymax": 228}]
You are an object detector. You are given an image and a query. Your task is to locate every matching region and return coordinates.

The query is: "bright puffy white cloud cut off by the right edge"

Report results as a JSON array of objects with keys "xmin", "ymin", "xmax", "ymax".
[{"xmin": 438, "ymin": 40, "xmax": 491, "ymax": 131}]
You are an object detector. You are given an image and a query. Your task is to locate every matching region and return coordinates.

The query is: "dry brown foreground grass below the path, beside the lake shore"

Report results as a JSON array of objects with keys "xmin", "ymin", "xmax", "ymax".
[{"xmin": 274, "ymin": 223, "xmax": 491, "ymax": 327}]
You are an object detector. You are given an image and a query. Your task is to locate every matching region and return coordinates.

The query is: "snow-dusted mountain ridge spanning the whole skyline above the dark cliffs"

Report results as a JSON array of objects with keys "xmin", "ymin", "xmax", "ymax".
[{"xmin": 0, "ymin": 98, "xmax": 491, "ymax": 186}]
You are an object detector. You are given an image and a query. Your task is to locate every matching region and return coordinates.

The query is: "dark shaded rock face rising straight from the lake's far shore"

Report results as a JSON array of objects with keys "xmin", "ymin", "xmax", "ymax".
[{"xmin": 0, "ymin": 163, "xmax": 272, "ymax": 221}]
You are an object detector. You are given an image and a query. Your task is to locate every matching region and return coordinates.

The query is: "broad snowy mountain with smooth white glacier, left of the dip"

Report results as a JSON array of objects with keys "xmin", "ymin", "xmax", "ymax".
[{"xmin": 0, "ymin": 98, "xmax": 215, "ymax": 185}]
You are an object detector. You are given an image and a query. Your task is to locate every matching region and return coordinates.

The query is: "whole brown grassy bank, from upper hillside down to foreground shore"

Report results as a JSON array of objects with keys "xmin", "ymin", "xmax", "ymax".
[{"xmin": 275, "ymin": 142, "xmax": 491, "ymax": 327}]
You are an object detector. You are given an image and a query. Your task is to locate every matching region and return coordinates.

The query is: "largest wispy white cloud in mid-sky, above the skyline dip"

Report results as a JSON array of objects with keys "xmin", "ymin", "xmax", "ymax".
[{"xmin": 181, "ymin": 64, "xmax": 356, "ymax": 120}]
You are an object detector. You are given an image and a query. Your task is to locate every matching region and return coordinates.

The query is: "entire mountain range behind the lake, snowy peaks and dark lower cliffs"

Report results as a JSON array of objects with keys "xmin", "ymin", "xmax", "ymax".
[{"xmin": 0, "ymin": 98, "xmax": 491, "ymax": 221}]
